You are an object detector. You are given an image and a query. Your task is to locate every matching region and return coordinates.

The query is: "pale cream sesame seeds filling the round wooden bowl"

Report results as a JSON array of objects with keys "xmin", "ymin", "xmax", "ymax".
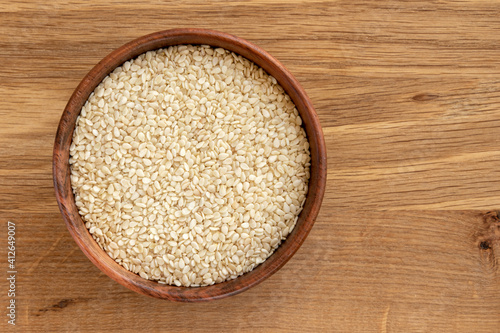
[{"xmin": 70, "ymin": 45, "xmax": 310, "ymax": 286}]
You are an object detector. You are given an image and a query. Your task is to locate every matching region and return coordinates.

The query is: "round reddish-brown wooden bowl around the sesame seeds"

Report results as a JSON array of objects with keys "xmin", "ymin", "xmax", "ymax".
[{"xmin": 53, "ymin": 29, "xmax": 326, "ymax": 302}]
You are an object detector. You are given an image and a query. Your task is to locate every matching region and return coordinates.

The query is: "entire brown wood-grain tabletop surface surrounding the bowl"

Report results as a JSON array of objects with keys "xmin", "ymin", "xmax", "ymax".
[{"xmin": 0, "ymin": 0, "xmax": 500, "ymax": 332}]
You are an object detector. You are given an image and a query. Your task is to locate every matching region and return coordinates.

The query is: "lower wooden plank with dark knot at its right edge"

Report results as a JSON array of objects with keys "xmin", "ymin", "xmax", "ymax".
[{"xmin": 0, "ymin": 210, "xmax": 500, "ymax": 332}]
